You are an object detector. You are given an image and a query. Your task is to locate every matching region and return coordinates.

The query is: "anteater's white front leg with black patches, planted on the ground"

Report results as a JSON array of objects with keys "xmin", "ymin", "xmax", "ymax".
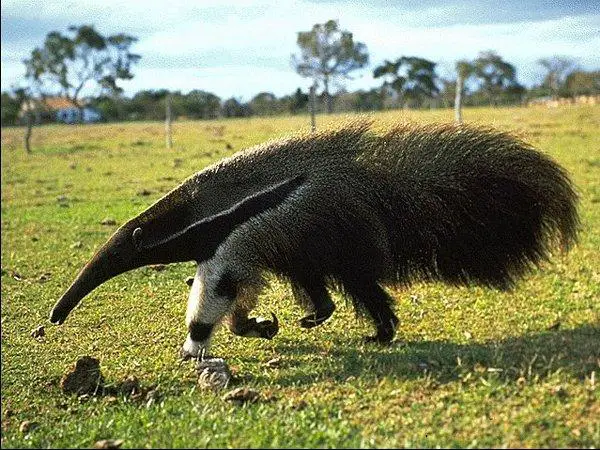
[{"xmin": 181, "ymin": 263, "xmax": 236, "ymax": 359}]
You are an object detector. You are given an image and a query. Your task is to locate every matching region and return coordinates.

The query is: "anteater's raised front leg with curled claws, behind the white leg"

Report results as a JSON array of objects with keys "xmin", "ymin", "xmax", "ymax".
[{"xmin": 226, "ymin": 280, "xmax": 279, "ymax": 339}]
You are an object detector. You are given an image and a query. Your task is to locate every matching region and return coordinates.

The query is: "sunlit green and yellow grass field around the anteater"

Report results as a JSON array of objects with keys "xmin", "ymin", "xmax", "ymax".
[{"xmin": 2, "ymin": 106, "xmax": 600, "ymax": 448}]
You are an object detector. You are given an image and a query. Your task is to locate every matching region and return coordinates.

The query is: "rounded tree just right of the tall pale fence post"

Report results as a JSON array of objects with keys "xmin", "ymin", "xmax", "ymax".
[{"xmin": 473, "ymin": 51, "xmax": 522, "ymax": 105}]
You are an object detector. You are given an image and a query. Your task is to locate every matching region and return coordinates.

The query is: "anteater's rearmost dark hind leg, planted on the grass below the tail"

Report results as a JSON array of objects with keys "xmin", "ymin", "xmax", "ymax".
[{"xmin": 344, "ymin": 281, "xmax": 399, "ymax": 344}]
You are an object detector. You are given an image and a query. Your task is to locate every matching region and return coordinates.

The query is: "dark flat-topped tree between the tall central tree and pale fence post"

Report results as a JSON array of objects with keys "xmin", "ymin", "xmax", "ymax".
[{"xmin": 373, "ymin": 56, "xmax": 439, "ymax": 107}]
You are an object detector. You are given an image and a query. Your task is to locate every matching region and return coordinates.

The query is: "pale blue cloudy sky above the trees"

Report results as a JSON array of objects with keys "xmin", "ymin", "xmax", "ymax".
[{"xmin": 1, "ymin": 0, "xmax": 600, "ymax": 101}]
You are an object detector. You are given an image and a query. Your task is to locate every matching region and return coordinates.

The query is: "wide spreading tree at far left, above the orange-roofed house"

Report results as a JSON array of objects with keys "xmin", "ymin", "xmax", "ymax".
[{"xmin": 24, "ymin": 25, "xmax": 140, "ymax": 119}]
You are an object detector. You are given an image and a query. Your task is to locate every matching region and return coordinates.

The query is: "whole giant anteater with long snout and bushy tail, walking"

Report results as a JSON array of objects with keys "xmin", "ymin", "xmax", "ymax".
[{"xmin": 51, "ymin": 120, "xmax": 578, "ymax": 356}]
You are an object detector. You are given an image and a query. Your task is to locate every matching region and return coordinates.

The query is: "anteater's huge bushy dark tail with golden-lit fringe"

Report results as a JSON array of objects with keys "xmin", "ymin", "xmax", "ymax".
[{"xmin": 359, "ymin": 124, "xmax": 578, "ymax": 288}]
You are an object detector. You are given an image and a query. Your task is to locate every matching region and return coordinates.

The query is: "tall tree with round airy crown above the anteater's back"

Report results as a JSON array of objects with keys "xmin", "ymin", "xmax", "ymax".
[{"xmin": 292, "ymin": 20, "xmax": 369, "ymax": 113}]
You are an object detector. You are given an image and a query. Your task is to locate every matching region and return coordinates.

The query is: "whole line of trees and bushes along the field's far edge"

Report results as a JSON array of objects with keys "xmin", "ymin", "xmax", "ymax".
[{"xmin": 2, "ymin": 20, "xmax": 600, "ymax": 125}]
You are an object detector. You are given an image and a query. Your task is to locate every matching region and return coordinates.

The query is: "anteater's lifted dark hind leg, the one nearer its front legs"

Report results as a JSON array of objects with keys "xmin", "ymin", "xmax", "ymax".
[{"xmin": 292, "ymin": 278, "xmax": 335, "ymax": 328}]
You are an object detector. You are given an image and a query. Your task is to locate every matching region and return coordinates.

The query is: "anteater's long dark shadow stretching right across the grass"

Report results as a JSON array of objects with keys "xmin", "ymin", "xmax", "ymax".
[{"xmin": 274, "ymin": 325, "xmax": 600, "ymax": 386}]
